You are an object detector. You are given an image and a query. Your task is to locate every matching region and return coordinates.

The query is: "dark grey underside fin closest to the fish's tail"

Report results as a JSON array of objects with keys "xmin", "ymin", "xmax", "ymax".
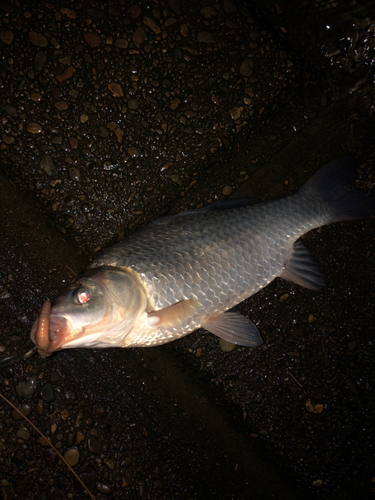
[{"xmin": 280, "ymin": 241, "xmax": 328, "ymax": 290}]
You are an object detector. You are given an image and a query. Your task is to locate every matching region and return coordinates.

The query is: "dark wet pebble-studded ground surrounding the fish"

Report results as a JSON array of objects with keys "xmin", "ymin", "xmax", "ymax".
[{"xmin": 0, "ymin": 0, "xmax": 375, "ymax": 500}]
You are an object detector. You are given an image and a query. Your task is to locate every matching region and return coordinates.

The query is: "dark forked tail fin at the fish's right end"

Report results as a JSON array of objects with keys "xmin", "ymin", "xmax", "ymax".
[{"xmin": 300, "ymin": 156, "xmax": 375, "ymax": 222}]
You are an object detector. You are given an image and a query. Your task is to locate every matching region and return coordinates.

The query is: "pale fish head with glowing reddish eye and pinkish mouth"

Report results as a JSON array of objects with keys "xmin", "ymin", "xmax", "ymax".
[{"xmin": 30, "ymin": 266, "xmax": 147, "ymax": 357}]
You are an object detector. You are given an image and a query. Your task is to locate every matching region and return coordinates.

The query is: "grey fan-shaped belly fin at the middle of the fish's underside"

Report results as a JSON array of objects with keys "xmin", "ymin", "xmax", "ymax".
[{"xmin": 202, "ymin": 311, "xmax": 263, "ymax": 347}]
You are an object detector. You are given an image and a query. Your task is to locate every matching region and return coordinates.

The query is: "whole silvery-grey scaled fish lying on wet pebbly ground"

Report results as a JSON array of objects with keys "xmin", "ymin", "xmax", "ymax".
[{"xmin": 30, "ymin": 156, "xmax": 375, "ymax": 357}]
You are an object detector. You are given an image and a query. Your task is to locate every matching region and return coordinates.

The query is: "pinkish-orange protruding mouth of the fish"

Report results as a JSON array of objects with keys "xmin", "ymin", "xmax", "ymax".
[{"xmin": 30, "ymin": 301, "xmax": 70, "ymax": 358}]
